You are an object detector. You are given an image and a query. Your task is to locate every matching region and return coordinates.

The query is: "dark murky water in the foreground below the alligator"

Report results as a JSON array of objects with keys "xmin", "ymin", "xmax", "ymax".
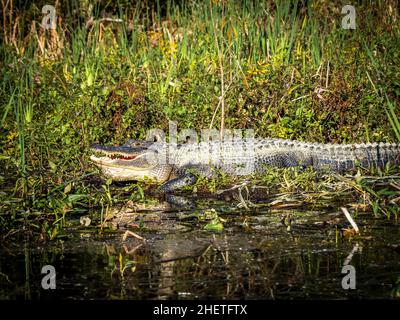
[{"xmin": 0, "ymin": 201, "xmax": 400, "ymax": 300}]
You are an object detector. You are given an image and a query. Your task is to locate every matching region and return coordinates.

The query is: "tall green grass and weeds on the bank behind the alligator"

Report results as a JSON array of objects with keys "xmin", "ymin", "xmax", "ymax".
[{"xmin": 0, "ymin": 0, "xmax": 400, "ymax": 240}]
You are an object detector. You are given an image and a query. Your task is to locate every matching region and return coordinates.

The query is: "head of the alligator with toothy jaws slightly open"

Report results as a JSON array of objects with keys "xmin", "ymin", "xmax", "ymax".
[{"xmin": 90, "ymin": 140, "xmax": 172, "ymax": 182}]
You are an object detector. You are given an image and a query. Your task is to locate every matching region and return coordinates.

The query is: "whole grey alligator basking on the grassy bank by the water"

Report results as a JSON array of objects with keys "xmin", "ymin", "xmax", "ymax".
[{"xmin": 90, "ymin": 138, "xmax": 400, "ymax": 193}]
